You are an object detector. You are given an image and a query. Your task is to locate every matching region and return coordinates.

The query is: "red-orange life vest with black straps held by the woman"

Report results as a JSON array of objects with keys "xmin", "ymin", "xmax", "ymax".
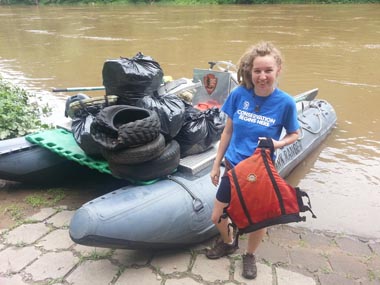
[{"xmin": 226, "ymin": 138, "xmax": 316, "ymax": 239}]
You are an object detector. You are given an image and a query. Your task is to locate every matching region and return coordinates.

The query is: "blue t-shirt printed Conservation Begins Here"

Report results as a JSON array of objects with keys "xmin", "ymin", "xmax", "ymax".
[{"xmin": 222, "ymin": 86, "xmax": 299, "ymax": 165}]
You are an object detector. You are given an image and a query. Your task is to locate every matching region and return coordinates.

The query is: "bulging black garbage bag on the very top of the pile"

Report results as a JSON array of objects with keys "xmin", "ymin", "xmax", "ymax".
[{"xmin": 102, "ymin": 52, "xmax": 164, "ymax": 105}]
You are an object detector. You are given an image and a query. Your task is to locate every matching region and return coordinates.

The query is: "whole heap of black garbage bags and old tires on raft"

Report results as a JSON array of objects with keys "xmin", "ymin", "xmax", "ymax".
[{"xmin": 65, "ymin": 53, "xmax": 226, "ymax": 181}]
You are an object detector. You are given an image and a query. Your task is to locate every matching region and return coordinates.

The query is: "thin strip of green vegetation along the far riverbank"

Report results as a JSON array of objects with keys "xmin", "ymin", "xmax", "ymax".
[{"xmin": 0, "ymin": 0, "xmax": 380, "ymax": 5}]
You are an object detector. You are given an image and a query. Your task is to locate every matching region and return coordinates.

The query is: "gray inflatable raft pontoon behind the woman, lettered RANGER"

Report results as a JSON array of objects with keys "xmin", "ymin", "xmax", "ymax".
[{"xmin": 69, "ymin": 91, "xmax": 336, "ymax": 249}]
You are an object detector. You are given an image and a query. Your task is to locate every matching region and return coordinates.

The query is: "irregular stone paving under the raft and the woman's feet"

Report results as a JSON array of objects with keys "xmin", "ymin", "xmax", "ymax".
[{"xmin": 0, "ymin": 207, "xmax": 380, "ymax": 285}]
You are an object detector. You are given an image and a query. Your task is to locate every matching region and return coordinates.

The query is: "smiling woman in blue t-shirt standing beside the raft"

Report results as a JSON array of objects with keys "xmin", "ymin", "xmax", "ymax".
[{"xmin": 206, "ymin": 42, "xmax": 299, "ymax": 279}]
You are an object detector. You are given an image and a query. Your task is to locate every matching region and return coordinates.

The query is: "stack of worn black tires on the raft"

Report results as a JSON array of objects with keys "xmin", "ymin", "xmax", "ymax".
[{"xmin": 91, "ymin": 105, "xmax": 180, "ymax": 181}]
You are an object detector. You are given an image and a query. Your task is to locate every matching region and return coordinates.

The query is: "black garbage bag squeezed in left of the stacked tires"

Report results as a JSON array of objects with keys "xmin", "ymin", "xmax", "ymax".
[{"xmin": 71, "ymin": 114, "xmax": 102, "ymax": 158}]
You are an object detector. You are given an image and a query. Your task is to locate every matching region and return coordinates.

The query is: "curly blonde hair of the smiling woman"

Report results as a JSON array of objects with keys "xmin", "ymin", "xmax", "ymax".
[{"xmin": 237, "ymin": 42, "xmax": 283, "ymax": 89}]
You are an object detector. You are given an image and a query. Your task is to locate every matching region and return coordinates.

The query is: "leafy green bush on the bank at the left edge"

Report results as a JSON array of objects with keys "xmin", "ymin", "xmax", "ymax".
[{"xmin": 0, "ymin": 77, "xmax": 51, "ymax": 140}]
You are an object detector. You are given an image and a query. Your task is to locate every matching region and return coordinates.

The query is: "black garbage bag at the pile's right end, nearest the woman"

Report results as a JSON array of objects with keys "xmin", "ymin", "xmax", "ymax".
[{"xmin": 175, "ymin": 105, "xmax": 226, "ymax": 158}]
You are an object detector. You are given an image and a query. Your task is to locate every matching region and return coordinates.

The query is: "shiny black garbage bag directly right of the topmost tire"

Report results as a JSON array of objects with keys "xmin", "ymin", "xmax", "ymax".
[{"xmin": 136, "ymin": 92, "xmax": 185, "ymax": 141}]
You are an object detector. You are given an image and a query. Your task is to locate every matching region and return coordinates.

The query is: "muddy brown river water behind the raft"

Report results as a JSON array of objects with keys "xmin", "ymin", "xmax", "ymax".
[{"xmin": 0, "ymin": 4, "xmax": 380, "ymax": 238}]
